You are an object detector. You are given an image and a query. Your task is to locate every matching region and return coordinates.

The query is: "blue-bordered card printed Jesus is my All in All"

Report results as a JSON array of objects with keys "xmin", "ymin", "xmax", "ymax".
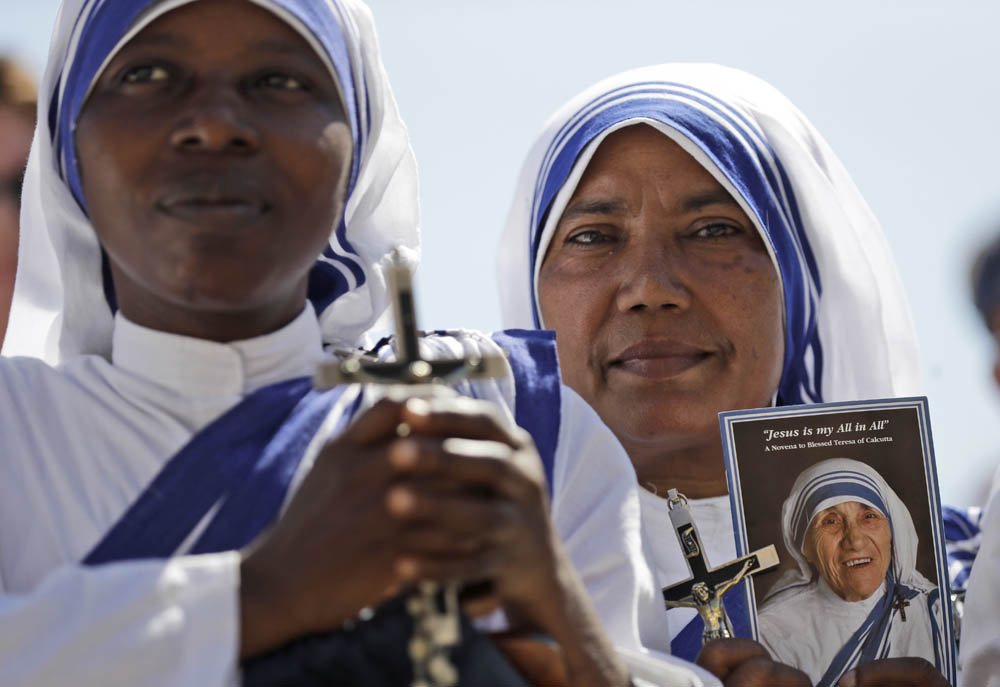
[{"xmin": 720, "ymin": 398, "xmax": 955, "ymax": 687}]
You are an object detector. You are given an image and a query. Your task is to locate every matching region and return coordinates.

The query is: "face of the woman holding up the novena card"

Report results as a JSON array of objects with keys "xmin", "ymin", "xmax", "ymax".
[{"xmin": 538, "ymin": 125, "xmax": 784, "ymax": 460}]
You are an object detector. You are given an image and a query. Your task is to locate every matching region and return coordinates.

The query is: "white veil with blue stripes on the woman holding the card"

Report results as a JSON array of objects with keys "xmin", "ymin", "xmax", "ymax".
[{"xmin": 498, "ymin": 64, "xmax": 919, "ymax": 405}]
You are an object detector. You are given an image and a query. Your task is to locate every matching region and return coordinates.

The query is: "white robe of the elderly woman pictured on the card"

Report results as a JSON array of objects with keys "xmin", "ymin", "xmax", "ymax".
[{"xmin": 757, "ymin": 577, "xmax": 941, "ymax": 684}]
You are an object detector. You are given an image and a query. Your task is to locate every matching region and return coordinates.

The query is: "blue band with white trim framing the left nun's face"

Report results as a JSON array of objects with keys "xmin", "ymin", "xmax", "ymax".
[{"xmin": 50, "ymin": 0, "xmax": 360, "ymax": 207}]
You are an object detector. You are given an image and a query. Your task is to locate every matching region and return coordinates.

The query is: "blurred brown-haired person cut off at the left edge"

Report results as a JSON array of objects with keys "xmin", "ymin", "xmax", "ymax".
[{"xmin": 0, "ymin": 57, "xmax": 37, "ymax": 344}]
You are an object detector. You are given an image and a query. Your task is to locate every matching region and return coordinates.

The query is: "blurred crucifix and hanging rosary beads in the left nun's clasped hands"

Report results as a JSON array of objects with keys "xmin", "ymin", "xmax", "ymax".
[{"xmin": 314, "ymin": 249, "xmax": 507, "ymax": 687}]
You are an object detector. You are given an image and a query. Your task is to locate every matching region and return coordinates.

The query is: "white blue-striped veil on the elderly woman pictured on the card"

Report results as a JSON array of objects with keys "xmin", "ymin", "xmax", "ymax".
[{"xmin": 768, "ymin": 458, "xmax": 934, "ymax": 596}]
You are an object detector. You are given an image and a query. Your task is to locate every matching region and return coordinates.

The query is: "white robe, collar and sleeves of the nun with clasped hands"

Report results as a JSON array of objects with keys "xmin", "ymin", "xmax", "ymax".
[{"xmin": 0, "ymin": 307, "xmax": 718, "ymax": 687}]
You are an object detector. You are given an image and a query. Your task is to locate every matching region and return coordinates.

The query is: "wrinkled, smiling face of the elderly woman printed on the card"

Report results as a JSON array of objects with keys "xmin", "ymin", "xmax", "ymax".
[{"xmin": 802, "ymin": 501, "xmax": 892, "ymax": 601}]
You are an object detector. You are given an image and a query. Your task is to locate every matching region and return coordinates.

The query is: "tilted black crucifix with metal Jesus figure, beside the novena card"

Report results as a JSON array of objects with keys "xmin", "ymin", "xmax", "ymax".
[{"xmin": 663, "ymin": 489, "xmax": 778, "ymax": 644}]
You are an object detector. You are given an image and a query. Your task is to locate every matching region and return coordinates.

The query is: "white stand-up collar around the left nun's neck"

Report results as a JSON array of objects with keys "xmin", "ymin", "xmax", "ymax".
[{"xmin": 111, "ymin": 303, "xmax": 324, "ymax": 398}]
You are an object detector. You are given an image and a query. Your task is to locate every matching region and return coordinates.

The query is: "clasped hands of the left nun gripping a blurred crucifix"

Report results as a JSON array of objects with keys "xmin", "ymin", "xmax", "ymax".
[{"xmin": 240, "ymin": 398, "xmax": 628, "ymax": 687}]
